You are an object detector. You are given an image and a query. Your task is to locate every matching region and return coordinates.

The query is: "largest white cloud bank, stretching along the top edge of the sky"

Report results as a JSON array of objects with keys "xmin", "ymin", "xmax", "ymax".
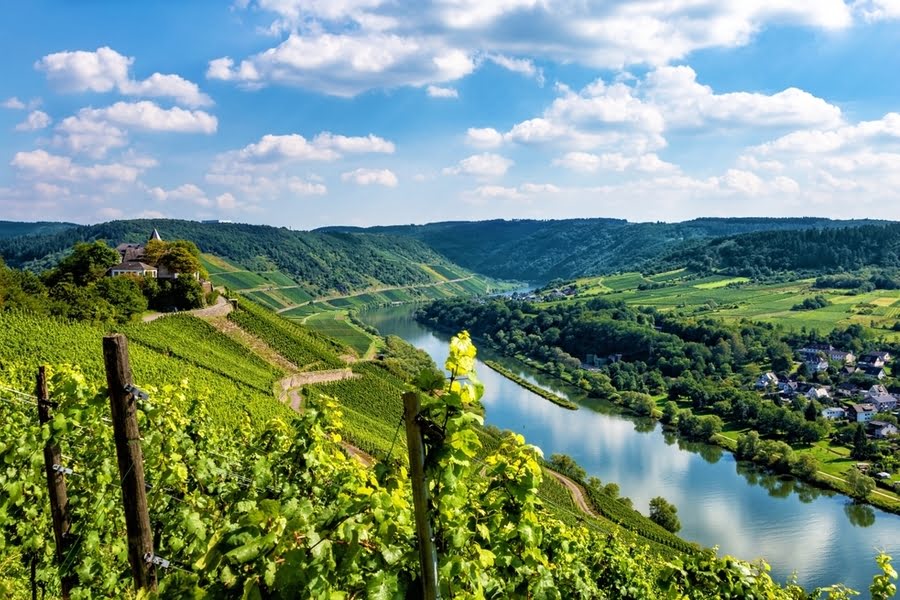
[{"xmin": 220, "ymin": 0, "xmax": 856, "ymax": 96}]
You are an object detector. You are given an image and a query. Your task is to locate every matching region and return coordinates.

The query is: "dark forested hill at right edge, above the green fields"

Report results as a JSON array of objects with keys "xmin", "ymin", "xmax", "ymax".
[{"xmin": 655, "ymin": 223, "xmax": 900, "ymax": 277}]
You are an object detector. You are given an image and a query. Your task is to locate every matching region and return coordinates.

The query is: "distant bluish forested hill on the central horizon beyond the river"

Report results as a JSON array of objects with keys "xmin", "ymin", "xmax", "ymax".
[{"xmin": 318, "ymin": 218, "xmax": 883, "ymax": 282}]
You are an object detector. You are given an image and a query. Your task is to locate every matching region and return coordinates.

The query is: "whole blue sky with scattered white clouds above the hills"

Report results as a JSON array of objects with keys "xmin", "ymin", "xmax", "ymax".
[{"xmin": 0, "ymin": 0, "xmax": 900, "ymax": 229}]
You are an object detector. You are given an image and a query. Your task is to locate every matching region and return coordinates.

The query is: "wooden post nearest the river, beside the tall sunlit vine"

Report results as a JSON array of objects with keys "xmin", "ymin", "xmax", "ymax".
[{"xmin": 403, "ymin": 392, "xmax": 441, "ymax": 600}]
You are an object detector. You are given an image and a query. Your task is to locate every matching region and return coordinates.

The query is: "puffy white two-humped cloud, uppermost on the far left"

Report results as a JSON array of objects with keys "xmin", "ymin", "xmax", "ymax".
[{"xmin": 35, "ymin": 47, "xmax": 213, "ymax": 107}]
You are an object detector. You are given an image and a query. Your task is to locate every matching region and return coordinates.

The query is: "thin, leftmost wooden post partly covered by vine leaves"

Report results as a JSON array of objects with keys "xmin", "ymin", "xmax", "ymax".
[{"xmin": 36, "ymin": 366, "xmax": 76, "ymax": 600}]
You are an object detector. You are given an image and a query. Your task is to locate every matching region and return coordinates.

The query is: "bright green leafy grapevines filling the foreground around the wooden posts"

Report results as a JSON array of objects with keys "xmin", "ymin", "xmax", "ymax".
[{"xmin": 0, "ymin": 322, "xmax": 890, "ymax": 600}]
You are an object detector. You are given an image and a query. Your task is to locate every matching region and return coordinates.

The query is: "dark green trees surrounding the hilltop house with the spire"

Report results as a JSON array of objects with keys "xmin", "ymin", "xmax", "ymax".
[{"xmin": 0, "ymin": 241, "xmax": 205, "ymax": 323}]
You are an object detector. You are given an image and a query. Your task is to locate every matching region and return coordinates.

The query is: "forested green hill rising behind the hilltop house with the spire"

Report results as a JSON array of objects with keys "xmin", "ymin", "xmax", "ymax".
[{"xmin": 0, "ymin": 219, "xmax": 478, "ymax": 295}]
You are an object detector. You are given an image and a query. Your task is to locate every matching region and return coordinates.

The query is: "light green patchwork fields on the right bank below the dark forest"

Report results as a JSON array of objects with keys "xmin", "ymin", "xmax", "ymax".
[{"xmin": 578, "ymin": 271, "xmax": 900, "ymax": 341}]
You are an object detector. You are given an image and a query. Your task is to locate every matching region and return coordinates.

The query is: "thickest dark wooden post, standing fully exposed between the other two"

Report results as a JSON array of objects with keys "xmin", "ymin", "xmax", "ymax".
[{"xmin": 103, "ymin": 333, "xmax": 156, "ymax": 590}]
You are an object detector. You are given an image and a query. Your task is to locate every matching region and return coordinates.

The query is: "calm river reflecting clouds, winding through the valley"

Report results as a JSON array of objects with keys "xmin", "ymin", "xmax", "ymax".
[{"xmin": 360, "ymin": 306, "xmax": 900, "ymax": 598}]
